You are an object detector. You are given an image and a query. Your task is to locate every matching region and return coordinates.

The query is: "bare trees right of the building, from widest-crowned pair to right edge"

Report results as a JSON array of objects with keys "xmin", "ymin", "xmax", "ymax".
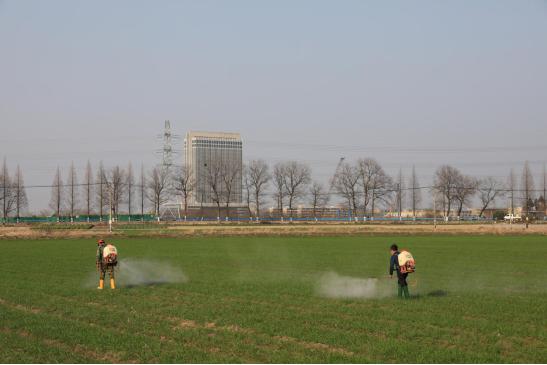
[{"xmin": 332, "ymin": 158, "xmax": 547, "ymax": 217}]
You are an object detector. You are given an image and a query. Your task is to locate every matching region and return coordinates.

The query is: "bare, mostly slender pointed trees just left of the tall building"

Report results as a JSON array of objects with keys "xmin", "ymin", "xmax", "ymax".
[{"xmin": 45, "ymin": 162, "xmax": 202, "ymax": 219}]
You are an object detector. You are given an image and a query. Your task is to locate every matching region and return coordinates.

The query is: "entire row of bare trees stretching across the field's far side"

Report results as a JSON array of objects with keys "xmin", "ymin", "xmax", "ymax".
[{"xmin": 0, "ymin": 158, "xmax": 547, "ymax": 218}]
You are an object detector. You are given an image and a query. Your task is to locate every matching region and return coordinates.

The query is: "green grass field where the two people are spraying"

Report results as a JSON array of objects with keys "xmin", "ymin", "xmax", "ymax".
[{"xmin": 0, "ymin": 236, "xmax": 547, "ymax": 363}]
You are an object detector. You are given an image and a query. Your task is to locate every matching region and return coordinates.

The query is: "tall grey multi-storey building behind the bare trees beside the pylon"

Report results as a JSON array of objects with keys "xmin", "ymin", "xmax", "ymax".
[{"xmin": 184, "ymin": 132, "xmax": 243, "ymax": 206}]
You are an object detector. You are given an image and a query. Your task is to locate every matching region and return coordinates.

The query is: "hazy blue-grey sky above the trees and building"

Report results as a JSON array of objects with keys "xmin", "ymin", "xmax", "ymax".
[{"xmin": 0, "ymin": 0, "xmax": 547, "ymax": 212}]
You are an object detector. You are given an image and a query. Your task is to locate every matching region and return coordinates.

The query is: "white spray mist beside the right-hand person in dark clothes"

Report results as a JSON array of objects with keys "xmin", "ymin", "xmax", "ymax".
[{"xmin": 316, "ymin": 272, "xmax": 393, "ymax": 299}]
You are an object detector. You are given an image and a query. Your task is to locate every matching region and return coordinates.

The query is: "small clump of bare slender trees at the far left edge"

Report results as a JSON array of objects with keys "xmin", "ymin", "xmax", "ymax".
[{"xmin": 0, "ymin": 159, "xmax": 28, "ymax": 222}]
